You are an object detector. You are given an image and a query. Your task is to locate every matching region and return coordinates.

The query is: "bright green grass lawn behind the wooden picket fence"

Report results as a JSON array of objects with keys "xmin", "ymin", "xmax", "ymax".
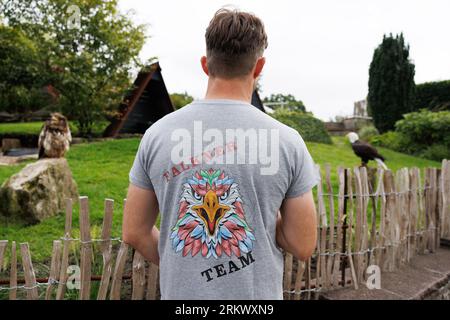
[{"xmin": 0, "ymin": 138, "xmax": 440, "ymax": 262}]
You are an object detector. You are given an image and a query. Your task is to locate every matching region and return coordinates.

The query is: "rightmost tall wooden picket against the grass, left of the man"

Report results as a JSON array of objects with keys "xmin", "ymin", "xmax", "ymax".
[{"xmin": 97, "ymin": 199, "xmax": 114, "ymax": 300}]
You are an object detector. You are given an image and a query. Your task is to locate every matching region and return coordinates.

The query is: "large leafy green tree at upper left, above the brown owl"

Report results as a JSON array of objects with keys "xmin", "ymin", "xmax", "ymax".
[{"xmin": 0, "ymin": 0, "xmax": 146, "ymax": 135}]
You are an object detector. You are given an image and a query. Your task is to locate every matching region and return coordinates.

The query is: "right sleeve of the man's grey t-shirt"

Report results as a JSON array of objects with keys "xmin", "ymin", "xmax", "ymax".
[{"xmin": 285, "ymin": 135, "xmax": 320, "ymax": 198}]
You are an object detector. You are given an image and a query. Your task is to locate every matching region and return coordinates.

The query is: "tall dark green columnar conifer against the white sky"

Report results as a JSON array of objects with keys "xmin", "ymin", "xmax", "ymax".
[{"xmin": 368, "ymin": 34, "xmax": 415, "ymax": 133}]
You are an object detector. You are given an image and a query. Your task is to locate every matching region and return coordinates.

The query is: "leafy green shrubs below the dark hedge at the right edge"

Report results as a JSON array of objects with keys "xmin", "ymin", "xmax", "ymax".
[{"xmin": 371, "ymin": 110, "xmax": 450, "ymax": 161}]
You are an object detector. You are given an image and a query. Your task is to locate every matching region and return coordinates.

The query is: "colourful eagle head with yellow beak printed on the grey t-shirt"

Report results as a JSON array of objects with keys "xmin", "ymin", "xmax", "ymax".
[{"xmin": 170, "ymin": 169, "xmax": 256, "ymax": 259}]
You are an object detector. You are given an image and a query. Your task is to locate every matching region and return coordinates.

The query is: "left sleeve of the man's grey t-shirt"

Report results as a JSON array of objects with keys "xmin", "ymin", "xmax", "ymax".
[{"xmin": 129, "ymin": 134, "xmax": 154, "ymax": 190}]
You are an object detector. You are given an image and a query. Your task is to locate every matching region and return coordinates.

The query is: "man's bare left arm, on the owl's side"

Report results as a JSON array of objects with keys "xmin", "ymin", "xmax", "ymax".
[{"xmin": 122, "ymin": 184, "xmax": 159, "ymax": 265}]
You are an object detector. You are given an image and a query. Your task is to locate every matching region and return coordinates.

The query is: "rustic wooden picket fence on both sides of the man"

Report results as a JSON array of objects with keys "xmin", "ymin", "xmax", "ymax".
[{"xmin": 0, "ymin": 160, "xmax": 450, "ymax": 300}]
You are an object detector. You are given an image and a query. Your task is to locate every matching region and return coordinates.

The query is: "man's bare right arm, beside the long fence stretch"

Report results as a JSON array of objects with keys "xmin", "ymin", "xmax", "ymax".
[{"xmin": 276, "ymin": 191, "xmax": 317, "ymax": 261}]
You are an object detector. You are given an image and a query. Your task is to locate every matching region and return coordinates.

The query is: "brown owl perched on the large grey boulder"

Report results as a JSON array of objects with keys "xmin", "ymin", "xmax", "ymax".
[{"xmin": 38, "ymin": 113, "xmax": 72, "ymax": 159}]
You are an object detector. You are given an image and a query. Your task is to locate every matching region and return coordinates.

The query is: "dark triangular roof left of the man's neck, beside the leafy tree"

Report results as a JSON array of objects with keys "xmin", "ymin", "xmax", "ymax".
[{"xmin": 103, "ymin": 62, "xmax": 175, "ymax": 137}]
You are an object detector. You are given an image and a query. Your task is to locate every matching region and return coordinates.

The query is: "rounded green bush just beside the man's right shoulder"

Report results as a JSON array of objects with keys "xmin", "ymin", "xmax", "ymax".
[{"xmin": 272, "ymin": 109, "xmax": 332, "ymax": 144}]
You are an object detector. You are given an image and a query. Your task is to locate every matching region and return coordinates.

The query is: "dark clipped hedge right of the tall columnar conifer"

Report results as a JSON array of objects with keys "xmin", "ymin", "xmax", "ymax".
[{"xmin": 414, "ymin": 80, "xmax": 450, "ymax": 111}]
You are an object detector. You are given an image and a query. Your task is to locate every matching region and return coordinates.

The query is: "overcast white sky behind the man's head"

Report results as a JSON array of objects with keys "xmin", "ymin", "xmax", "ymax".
[{"xmin": 120, "ymin": 0, "xmax": 450, "ymax": 120}]
